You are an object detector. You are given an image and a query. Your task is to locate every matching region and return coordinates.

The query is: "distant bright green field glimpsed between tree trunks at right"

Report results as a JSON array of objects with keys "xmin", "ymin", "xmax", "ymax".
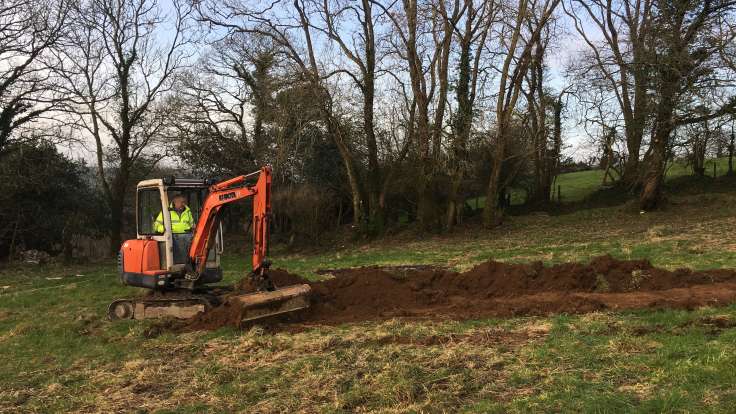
[{"xmin": 467, "ymin": 158, "xmax": 728, "ymax": 210}]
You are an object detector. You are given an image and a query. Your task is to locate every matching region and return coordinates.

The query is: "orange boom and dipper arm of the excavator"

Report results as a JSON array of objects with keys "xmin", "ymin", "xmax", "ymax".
[{"xmin": 187, "ymin": 166, "xmax": 271, "ymax": 280}]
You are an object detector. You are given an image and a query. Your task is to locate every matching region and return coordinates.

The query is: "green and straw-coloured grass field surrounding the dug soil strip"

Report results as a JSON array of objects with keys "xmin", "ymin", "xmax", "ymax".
[{"xmin": 0, "ymin": 173, "xmax": 736, "ymax": 413}]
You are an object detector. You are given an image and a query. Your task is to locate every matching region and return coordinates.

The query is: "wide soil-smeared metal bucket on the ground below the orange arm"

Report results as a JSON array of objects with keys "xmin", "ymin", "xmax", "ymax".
[{"xmin": 229, "ymin": 284, "xmax": 312, "ymax": 322}]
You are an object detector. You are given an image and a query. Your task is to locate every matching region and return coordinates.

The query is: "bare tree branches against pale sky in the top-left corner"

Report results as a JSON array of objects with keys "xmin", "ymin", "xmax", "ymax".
[{"xmin": 0, "ymin": 0, "xmax": 69, "ymax": 152}]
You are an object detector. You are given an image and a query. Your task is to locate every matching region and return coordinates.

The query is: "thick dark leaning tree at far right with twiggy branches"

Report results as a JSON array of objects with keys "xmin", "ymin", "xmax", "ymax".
[{"xmin": 639, "ymin": 0, "xmax": 736, "ymax": 210}]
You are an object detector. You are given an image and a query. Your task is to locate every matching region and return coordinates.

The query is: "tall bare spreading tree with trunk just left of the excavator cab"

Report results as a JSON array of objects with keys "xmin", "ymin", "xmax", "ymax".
[{"xmin": 56, "ymin": 0, "xmax": 191, "ymax": 254}]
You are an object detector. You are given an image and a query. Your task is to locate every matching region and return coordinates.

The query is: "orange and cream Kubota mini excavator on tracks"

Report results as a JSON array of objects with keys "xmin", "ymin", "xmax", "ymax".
[{"xmin": 108, "ymin": 167, "xmax": 310, "ymax": 322}]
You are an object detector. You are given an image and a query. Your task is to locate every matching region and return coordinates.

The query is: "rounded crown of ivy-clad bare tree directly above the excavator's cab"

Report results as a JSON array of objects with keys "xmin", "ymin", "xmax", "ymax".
[{"xmin": 172, "ymin": 33, "xmax": 286, "ymax": 174}]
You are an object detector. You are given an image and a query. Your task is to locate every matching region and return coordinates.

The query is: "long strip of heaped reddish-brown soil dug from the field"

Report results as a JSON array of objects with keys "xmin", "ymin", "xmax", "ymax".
[{"xmin": 184, "ymin": 256, "xmax": 736, "ymax": 330}]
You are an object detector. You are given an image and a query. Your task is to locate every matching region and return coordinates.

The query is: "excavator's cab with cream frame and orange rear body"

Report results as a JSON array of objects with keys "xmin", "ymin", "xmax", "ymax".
[{"xmin": 120, "ymin": 178, "xmax": 223, "ymax": 290}]
